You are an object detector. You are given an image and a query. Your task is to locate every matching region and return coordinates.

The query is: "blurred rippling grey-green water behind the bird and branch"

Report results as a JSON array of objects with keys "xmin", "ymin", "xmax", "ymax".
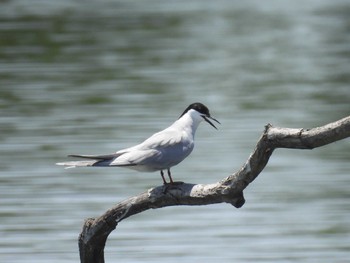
[{"xmin": 0, "ymin": 0, "xmax": 350, "ymax": 263}]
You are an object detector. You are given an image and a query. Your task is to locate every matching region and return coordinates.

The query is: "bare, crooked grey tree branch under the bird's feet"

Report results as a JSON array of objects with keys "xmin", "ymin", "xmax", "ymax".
[{"xmin": 79, "ymin": 116, "xmax": 350, "ymax": 263}]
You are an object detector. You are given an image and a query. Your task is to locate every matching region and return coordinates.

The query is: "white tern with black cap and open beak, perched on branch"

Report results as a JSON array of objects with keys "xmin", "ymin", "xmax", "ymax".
[{"xmin": 57, "ymin": 102, "xmax": 220, "ymax": 184}]
